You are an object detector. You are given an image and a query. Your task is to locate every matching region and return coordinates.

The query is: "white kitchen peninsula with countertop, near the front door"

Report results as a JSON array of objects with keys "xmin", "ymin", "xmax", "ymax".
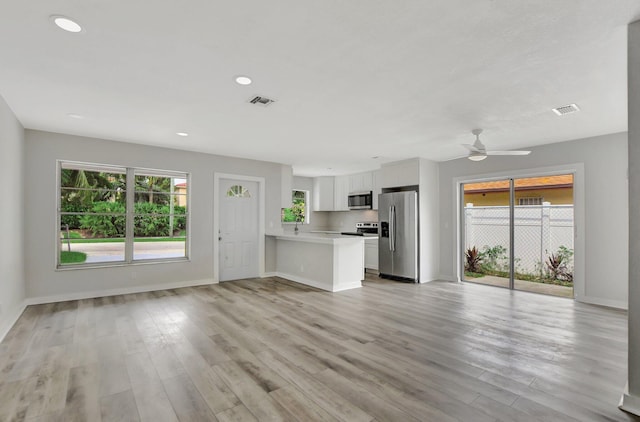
[{"xmin": 266, "ymin": 233, "xmax": 364, "ymax": 292}]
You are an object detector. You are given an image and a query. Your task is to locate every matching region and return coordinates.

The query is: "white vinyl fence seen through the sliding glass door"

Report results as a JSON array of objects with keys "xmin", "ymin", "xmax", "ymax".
[{"xmin": 464, "ymin": 202, "xmax": 573, "ymax": 274}]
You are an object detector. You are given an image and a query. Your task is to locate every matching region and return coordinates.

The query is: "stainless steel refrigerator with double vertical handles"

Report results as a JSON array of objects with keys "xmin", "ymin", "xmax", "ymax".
[{"xmin": 378, "ymin": 191, "xmax": 419, "ymax": 283}]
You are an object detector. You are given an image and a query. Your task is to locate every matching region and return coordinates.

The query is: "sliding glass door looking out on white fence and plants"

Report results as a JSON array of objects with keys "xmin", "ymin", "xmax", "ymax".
[{"xmin": 460, "ymin": 173, "xmax": 575, "ymax": 298}]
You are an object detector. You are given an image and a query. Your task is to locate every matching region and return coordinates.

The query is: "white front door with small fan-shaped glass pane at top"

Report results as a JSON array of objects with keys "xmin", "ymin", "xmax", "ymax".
[{"xmin": 218, "ymin": 179, "xmax": 259, "ymax": 281}]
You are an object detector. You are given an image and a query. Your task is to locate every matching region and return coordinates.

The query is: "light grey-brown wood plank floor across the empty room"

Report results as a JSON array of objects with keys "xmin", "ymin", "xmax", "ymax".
[{"xmin": 0, "ymin": 276, "xmax": 635, "ymax": 422}]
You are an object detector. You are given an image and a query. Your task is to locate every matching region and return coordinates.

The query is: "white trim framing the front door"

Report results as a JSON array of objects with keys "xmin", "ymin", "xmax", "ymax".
[{"xmin": 213, "ymin": 172, "xmax": 265, "ymax": 283}]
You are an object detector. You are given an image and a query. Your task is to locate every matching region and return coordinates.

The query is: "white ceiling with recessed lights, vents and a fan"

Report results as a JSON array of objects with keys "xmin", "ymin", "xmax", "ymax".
[{"xmin": 0, "ymin": 0, "xmax": 640, "ymax": 176}]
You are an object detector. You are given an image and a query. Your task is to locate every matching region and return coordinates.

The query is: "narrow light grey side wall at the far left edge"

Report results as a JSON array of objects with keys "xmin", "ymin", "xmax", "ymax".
[{"xmin": 0, "ymin": 97, "xmax": 25, "ymax": 340}]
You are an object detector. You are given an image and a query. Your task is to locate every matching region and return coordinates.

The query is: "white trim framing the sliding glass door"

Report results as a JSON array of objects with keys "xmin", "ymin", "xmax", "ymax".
[{"xmin": 451, "ymin": 163, "xmax": 592, "ymax": 303}]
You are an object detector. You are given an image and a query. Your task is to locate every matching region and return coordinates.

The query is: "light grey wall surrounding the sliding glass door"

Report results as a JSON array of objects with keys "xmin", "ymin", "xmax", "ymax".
[{"xmin": 439, "ymin": 133, "xmax": 629, "ymax": 308}]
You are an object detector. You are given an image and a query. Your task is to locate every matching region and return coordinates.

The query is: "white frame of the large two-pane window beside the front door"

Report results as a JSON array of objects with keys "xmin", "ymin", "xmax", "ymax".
[{"xmin": 55, "ymin": 160, "xmax": 191, "ymax": 271}]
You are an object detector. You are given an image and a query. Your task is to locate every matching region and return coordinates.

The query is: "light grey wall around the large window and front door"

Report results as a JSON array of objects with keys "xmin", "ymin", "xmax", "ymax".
[{"xmin": 24, "ymin": 130, "xmax": 282, "ymax": 299}]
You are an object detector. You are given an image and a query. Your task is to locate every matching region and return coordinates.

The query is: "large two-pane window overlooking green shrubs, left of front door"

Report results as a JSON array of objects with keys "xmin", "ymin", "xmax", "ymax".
[{"xmin": 57, "ymin": 162, "xmax": 189, "ymax": 268}]
